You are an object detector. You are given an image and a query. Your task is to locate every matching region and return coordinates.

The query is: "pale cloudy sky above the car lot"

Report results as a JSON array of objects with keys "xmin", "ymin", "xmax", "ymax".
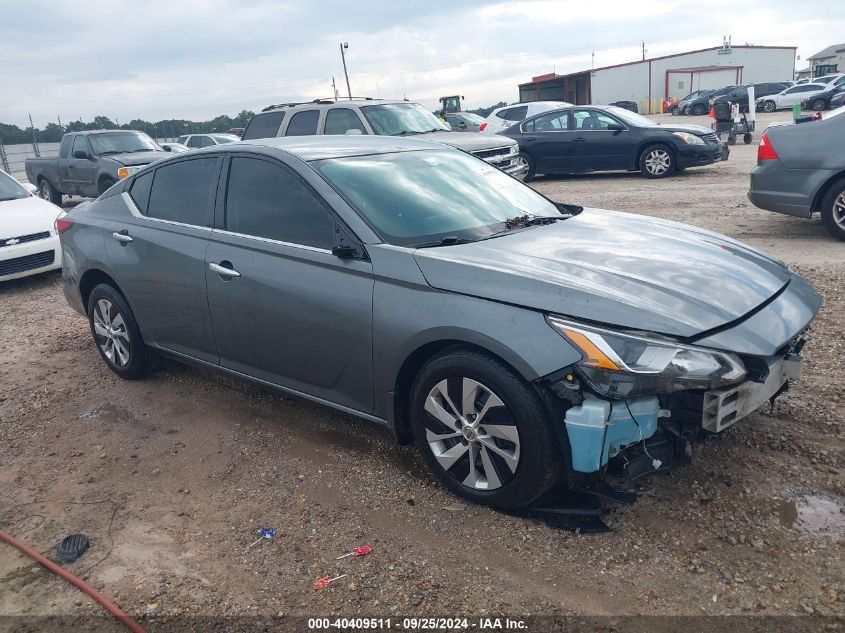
[{"xmin": 0, "ymin": 0, "xmax": 845, "ymax": 127}]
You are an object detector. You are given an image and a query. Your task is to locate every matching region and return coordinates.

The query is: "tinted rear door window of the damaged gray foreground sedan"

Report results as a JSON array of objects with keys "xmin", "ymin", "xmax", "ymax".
[{"xmin": 147, "ymin": 158, "xmax": 218, "ymax": 226}]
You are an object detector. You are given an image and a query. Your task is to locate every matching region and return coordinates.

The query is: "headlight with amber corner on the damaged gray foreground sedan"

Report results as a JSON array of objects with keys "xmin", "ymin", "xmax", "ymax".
[{"xmin": 546, "ymin": 316, "xmax": 746, "ymax": 398}]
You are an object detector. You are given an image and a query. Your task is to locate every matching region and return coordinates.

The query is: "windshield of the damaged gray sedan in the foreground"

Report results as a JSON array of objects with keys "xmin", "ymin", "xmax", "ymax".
[{"xmin": 316, "ymin": 150, "xmax": 561, "ymax": 246}]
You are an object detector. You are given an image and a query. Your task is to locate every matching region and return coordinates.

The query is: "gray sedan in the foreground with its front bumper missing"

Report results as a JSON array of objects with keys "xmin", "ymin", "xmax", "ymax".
[{"xmin": 57, "ymin": 136, "xmax": 819, "ymax": 507}]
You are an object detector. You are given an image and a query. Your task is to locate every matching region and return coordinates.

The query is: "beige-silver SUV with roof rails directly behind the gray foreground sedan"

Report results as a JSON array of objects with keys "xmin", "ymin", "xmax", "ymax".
[{"xmin": 243, "ymin": 97, "xmax": 528, "ymax": 180}]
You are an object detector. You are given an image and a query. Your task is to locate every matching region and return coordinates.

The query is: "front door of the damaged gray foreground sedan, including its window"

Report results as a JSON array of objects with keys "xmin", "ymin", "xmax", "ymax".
[{"xmin": 206, "ymin": 155, "xmax": 374, "ymax": 412}]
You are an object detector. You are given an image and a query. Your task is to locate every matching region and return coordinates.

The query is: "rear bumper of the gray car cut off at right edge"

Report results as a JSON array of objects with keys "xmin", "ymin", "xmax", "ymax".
[{"xmin": 748, "ymin": 160, "xmax": 835, "ymax": 218}]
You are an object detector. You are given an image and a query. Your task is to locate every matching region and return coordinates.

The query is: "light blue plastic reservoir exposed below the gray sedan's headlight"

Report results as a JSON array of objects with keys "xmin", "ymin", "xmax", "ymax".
[{"xmin": 565, "ymin": 396, "xmax": 660, "ymax": 473}]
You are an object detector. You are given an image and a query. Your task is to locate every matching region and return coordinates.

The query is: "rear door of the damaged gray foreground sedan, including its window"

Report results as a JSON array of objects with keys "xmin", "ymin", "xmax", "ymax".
[{"xmin": 106, "ymin": 156, "xmax": 222, "ymax": 363}]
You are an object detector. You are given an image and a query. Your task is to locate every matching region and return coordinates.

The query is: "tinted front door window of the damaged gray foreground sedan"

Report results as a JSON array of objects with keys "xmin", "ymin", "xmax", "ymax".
[{"xmin": 226, "ymin": 156, "xmax": 334, "ymax": 249}]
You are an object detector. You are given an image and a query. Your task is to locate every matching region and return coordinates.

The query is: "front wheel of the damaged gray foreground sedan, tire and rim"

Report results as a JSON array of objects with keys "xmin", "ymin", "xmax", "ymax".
[{"xmin": 410, "ymin": 348, "xmax": 563, "ymax": 508}]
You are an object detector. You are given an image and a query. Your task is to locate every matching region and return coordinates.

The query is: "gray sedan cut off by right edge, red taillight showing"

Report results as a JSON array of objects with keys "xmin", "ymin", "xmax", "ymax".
[{"xmin": 748, "ymin": 106, "xmax": 845, "ymax": 240}]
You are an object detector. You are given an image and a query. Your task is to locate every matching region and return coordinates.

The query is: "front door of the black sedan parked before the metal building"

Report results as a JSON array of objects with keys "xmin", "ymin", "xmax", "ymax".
[{"xmin": 570, "ymin": 109, "xmax": 634, "ymax": 172}]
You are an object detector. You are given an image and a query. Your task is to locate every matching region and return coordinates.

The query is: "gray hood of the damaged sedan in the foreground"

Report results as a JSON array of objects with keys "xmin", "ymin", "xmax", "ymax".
[{"xmin": 414, "ymin": 209, "xmax": 790, "ymax": 338}]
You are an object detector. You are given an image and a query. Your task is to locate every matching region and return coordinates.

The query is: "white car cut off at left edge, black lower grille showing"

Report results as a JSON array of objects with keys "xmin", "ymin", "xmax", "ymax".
[{"xmin": 0, "ymin": 171, "xmax": 64, "ymax": 281}]
